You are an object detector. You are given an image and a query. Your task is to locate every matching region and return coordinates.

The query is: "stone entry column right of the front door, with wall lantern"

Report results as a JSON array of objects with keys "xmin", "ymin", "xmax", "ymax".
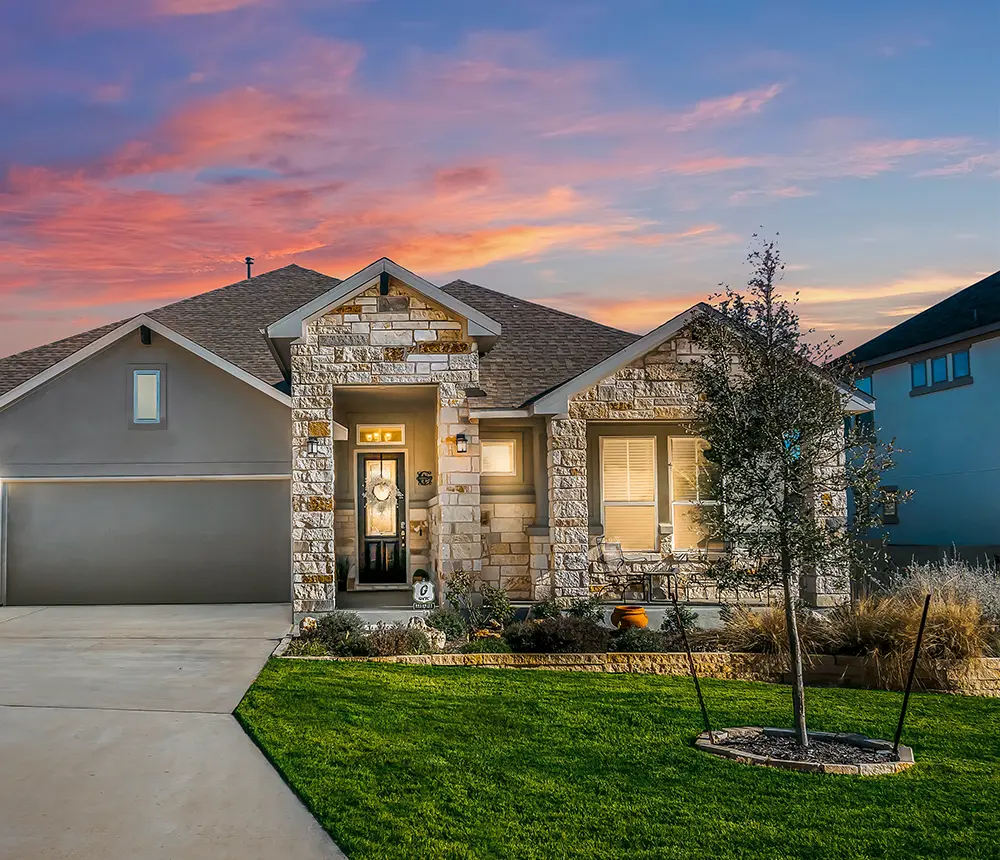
[{"xmin": 432, "ymin": 382, "xmax": 483, "ymax": 583}]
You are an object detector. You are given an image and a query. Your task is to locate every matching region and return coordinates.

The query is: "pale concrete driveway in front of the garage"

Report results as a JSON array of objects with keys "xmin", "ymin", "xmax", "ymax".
[{"xmin": 0, "ymin": 605, "xmax": 344, "ymax": 860}]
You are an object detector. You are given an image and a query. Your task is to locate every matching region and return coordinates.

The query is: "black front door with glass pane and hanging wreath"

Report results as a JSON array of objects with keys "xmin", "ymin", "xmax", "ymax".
[{"xmin": 358, "ymin": 453, "xmax": 406, "ymax": 585}]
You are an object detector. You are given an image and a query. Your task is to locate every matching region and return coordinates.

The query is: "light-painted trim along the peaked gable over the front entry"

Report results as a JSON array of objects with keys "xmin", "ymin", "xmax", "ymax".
[{"xmin": 267, "ymin": 257, "xmax": 501, "ymax": 340}]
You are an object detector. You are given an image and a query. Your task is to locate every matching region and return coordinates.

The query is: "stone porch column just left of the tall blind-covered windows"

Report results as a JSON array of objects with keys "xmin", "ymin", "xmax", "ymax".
[{"xmin": 546, "ymin": 418, "xmax": 590, "ymax": 597}]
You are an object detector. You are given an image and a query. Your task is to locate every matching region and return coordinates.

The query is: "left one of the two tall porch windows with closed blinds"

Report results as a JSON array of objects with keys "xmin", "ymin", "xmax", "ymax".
[{"xmin": 601, "ymin": 436, "xmax": 659, "ymax": 552}]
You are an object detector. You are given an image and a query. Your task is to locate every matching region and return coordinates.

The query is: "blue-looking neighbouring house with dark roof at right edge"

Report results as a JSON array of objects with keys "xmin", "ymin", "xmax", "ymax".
[{"xmin": 852, "ymin": 272, "xmax": 1000, "ymax": 563}]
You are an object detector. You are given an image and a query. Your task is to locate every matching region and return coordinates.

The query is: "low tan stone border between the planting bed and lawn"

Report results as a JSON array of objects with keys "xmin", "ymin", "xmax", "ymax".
[{"xmin": 274, "ymin": 640, "xmax": 1000, "ymax": 697}]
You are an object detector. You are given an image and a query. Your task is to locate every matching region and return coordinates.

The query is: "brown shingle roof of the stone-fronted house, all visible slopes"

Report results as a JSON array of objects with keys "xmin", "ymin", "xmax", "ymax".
[{"xmin": 0, "ymin": 265, "xmax": 639, "ymax": 408}]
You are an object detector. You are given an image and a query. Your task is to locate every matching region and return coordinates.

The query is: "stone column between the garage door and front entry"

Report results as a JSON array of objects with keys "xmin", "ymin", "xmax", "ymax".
[{"xmin": 292, "ymin": 344, "xmax": 337, "ymax": 622}]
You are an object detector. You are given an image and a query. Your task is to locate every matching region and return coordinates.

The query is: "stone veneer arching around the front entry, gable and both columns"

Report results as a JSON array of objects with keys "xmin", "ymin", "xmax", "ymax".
[{"xmin": 292, "ymin": 284, "xmax": 482, "ymax": 616}]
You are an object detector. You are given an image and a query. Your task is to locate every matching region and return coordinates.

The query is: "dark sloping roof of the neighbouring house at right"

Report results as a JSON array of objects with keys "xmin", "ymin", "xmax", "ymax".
[{"xmin": 851, "ymin": 272, "xmax": 1000, "ymax": 364}]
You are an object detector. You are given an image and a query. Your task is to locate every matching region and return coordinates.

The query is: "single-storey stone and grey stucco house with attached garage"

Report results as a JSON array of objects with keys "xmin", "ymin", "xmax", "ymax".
[{"xmin": 0, "ymin": 258, "xmax": 870, "ymax": 617}]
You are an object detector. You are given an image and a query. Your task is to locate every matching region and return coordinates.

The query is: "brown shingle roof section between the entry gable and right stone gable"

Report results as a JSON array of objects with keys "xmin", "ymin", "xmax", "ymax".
[{"xmin": 441, "ymin": 280, "xmax": 639, "ymax": 408}]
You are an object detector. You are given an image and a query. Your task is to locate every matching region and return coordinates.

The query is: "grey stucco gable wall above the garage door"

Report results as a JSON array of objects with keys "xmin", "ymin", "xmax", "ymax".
[{"xmin": 0, "ymin": 331, "xmax": 291, "ymax": 477}]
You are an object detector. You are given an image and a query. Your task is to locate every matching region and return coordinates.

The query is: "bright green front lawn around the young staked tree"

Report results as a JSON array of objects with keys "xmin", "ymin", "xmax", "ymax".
[{"xmin": 236, "ymin": 660, "xmax": 1000, "ymax": 860}]
